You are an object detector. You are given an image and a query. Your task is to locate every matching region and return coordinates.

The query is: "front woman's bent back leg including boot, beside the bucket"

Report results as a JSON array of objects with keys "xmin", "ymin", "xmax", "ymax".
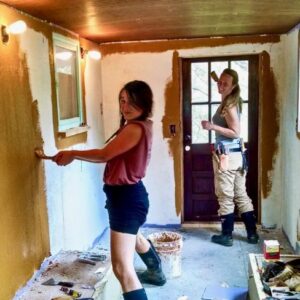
[{"xmin": 135, "ymin": 233, "xmax": 167, "ymax": 286}]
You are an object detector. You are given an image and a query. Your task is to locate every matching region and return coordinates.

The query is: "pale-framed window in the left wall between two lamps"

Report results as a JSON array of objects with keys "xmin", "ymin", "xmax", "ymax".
[{"xmin": 53, "ymin": 33, "xmax": 83, "ymax": 132}]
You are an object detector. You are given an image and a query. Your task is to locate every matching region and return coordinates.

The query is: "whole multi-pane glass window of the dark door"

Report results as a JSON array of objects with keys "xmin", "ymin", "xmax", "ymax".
[{"xmin": 191, "ymin": 58, "xmax": 249, "ymax": 144}]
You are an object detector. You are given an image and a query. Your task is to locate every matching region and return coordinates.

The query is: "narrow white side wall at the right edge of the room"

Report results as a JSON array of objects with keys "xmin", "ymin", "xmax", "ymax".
[{"xmin": 281, "ymin": 27, "xmax": 300, "ymax": 247}]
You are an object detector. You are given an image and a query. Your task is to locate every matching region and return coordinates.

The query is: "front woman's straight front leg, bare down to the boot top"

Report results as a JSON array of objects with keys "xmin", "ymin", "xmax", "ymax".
[{"xmin": 110, "ymin": 230, "xmax": 147, "ymax": 300}]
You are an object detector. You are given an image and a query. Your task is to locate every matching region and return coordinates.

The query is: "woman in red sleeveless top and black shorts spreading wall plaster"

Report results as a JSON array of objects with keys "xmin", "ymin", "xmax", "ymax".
[{"xmin": 53, "ymin": 80, "xmax": 166, "ymax": 300}]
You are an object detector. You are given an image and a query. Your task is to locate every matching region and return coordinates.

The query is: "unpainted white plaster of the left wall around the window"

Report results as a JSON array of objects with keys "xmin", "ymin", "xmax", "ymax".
[{"xmin": 21, "ymin": 28, "xmax": 108, "ymax": 254}]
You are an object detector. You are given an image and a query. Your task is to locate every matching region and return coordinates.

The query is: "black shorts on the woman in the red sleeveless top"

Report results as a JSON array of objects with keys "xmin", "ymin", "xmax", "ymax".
[{"xmin": 103, "ymin": 181, "xmax": 149, "ymax": 234}]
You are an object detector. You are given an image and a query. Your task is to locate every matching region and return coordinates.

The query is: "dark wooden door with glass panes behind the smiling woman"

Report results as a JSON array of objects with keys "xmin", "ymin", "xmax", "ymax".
[{"xmin": 182, "ymin": 55, "xmax": 258, "ymax": 222}]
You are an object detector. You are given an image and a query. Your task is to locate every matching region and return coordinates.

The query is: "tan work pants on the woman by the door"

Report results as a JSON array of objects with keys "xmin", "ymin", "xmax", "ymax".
[{"xmin": 213, "ymin": 152, "xmax": 253, "ymax": 216}]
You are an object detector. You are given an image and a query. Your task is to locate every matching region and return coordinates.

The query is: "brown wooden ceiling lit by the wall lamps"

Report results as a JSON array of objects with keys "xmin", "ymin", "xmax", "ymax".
[{"xmin": 0, "ymin": 0, "xmax": 300, "ymax": 43}]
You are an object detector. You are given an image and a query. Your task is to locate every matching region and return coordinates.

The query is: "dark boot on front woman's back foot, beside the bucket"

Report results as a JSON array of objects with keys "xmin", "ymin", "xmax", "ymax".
[{"xmin": 138, "ymin": 240, "xmax": 167, "ymax": 286}]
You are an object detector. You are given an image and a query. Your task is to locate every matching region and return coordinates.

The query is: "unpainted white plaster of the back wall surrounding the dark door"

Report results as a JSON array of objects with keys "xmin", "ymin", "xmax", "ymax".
[{"xmin": 102, "ymin": 43, "xmax": 284, "ymax": 225}]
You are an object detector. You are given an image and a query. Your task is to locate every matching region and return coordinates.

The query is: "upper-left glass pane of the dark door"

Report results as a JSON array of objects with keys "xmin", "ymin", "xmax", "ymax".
[{"xmin": 191, "ymin": 63, "xmax": 208, "ymax": 103}]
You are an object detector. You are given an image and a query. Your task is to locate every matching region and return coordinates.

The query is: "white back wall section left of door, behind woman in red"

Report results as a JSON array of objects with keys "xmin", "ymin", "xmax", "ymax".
[{"xmin": 102, "ymin": 52, "xmax": 180, "ymax": 224}]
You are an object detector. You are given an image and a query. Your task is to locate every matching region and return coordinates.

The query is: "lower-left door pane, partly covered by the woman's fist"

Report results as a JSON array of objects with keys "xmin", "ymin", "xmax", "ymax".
[{"xmin": 192, "ymin": 105, "xmax": 208, "ymax": 144}]
